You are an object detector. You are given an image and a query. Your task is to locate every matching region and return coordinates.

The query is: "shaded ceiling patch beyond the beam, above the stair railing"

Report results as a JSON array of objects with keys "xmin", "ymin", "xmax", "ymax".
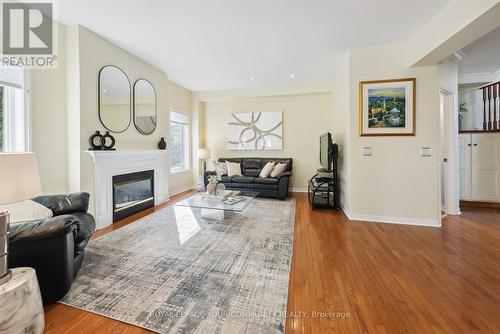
[{"xmin": 459, "ymin": 28, "xmax": 500, "ymax": 73}]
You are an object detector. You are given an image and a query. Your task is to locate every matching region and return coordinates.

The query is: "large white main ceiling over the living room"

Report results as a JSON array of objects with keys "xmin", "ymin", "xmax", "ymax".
[{"xmin": 57, "ymin": 0, "xmax": 447, "ymax": 91}]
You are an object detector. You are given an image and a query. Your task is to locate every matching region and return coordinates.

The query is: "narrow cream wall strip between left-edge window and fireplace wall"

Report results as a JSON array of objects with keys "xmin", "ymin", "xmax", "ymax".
[{"xmin": 30, "ymin": 24, "xmax": 68, "ymax": 194}]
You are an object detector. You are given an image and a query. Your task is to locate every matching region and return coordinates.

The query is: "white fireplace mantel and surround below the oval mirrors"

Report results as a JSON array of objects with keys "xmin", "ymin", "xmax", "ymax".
[{"xmin": 85, "ymin": 150, "xmax": 169, "ymax": 229}]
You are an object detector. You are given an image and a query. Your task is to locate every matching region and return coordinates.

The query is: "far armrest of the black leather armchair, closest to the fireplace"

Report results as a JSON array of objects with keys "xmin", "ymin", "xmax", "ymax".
[{"xmin": 33, "ymin": 192, "xmax": 90, "ymax": 216}]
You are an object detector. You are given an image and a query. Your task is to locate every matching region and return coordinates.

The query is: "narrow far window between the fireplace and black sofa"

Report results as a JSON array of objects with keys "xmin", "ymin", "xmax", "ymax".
[{"xmin": 170, "ymin": 109, "xmax": 190, "ymax": 173}]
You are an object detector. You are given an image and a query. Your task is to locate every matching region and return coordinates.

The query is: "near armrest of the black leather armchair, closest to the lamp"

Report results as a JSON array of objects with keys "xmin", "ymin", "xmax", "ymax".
[{"xmin": 9, "ymin": 215, "xmax": 77, "ymax": 245}]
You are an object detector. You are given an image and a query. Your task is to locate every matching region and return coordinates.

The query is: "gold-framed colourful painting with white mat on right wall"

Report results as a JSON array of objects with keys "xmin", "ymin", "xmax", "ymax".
[{"xmin": 359, "ymin": 78, "xmax": 416, "ymax": 136}]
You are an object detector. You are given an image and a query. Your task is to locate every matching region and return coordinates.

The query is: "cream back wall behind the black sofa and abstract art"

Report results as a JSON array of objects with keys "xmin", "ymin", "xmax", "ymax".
[{"xmin": 201, "ymin": 93, "xmax": 335, "ymax": 191}]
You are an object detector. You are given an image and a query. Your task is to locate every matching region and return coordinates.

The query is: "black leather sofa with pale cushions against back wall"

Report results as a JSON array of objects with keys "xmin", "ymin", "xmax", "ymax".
[{"xmin": 203, "ymin": 158, "xmax": 293, "ymax": 200}]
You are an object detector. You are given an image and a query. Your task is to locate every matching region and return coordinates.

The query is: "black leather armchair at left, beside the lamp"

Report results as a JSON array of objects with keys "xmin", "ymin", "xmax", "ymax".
[{"xmin": 9, "ymin": 193, "xmax": 95, "ymax": 305}]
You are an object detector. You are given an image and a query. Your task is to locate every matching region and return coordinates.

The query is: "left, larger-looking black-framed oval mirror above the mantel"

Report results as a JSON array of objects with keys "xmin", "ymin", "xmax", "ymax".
[{"xmin": 98, "ymin": 65, "xmax": 132, "ymax": 132}]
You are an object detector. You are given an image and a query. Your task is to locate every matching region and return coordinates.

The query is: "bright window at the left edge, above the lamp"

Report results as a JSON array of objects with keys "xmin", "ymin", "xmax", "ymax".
[{"xmin": 0, "ymin": 66, "xmax": 30, "ymax": 152}]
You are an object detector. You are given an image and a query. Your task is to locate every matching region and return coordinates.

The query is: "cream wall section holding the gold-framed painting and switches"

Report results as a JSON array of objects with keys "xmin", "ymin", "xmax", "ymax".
[{"xmin": 340, "ymin": 44, "xmax": 440, "ymax": 226}]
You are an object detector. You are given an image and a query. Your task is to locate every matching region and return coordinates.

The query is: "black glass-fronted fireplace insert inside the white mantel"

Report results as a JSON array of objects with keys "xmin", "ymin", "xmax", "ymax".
[{"xmin": 113, "ymin": 170, "xmax": 155, "ymax": 222}]
